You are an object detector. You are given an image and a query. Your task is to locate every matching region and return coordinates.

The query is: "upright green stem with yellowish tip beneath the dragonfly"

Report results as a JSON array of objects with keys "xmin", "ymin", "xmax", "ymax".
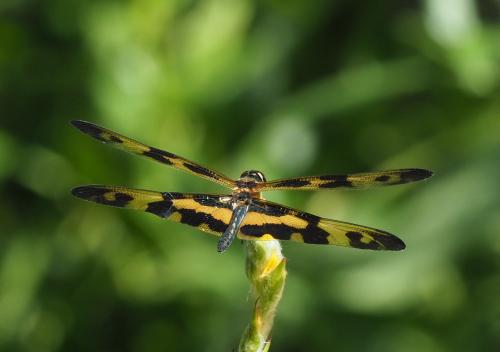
[{"xmin": 238, "ymin": 240, "xmax": 286, "ymax": 352}]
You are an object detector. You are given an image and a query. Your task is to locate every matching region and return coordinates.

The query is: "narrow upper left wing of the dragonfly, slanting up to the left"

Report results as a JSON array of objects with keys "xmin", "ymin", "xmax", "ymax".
[{"xmin": 71, "ymin": 120, "xmax": 236, "ymax": 188}]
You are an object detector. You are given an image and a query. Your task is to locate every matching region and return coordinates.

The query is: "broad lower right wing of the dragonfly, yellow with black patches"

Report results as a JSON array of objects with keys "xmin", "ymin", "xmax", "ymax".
[{"xmin": 238, "ymin": 199, "xmax": 405, "ymax": 251}]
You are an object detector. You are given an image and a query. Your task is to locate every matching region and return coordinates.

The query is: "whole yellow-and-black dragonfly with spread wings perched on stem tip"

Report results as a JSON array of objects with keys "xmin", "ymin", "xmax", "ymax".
[{"xmin": 71, "ymin": 120, "xmax": 433, "ymax": 252}]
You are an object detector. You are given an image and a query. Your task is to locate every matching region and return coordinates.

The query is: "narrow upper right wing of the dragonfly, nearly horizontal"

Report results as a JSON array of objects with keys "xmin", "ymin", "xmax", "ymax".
[{"xmin": 256, "ymin": 169, "xmax": 432, "ymax": 191}]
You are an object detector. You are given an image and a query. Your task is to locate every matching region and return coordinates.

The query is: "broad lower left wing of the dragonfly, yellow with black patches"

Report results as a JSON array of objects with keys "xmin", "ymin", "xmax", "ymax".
[{"xmin": 72, "ymin": 185, "xmax": 232, "ymax": 236}]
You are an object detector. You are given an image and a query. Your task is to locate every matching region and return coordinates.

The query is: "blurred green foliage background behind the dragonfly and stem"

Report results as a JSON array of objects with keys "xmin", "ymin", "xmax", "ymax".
[{"xmin": 0, "ymin": 0, "xmax": 500, "ymax": 352}]
